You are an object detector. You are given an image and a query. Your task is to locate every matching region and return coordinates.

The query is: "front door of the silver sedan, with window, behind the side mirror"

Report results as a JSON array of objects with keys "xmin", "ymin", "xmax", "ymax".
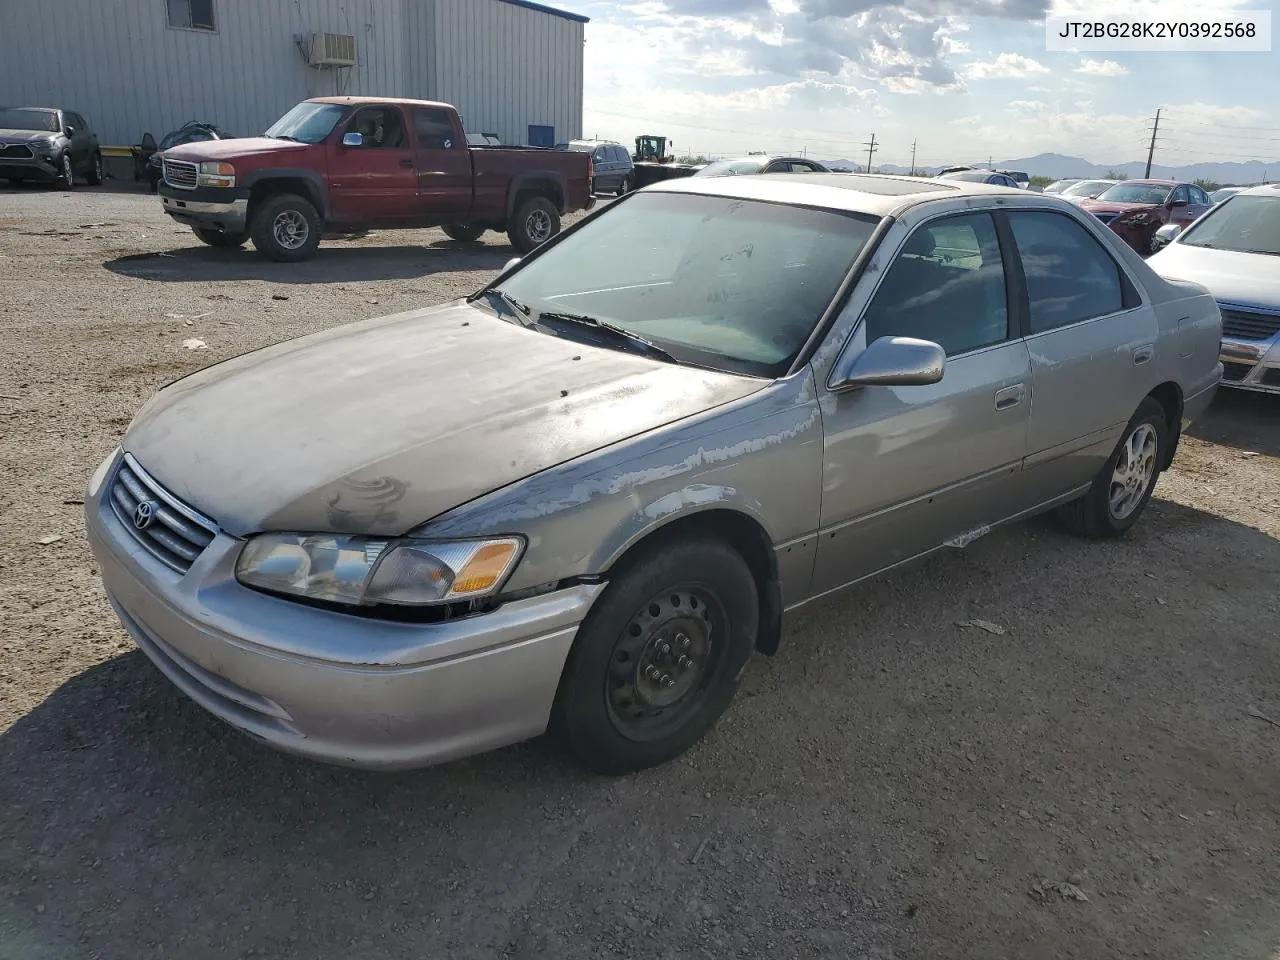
[{"xmin": 814, "ymin": 214, "xmax": 1032, "ymax": 593}]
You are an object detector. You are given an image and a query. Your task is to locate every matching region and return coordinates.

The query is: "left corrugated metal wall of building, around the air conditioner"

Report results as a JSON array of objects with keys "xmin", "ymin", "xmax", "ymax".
[{"xmin": 0, "ymin": 0, "xmax": 406, "ymax": 145}]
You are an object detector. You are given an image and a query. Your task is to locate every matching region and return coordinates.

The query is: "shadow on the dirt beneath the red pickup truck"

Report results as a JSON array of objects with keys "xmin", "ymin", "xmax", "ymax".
[{"xmin": 102, "ymin": 241, "xmax": 516, "ymax": 284}]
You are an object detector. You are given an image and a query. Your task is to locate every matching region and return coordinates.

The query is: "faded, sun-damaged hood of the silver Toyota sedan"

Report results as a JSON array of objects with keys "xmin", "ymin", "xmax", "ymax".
[{"xmin": 123, "ymin": 301, "xmax": 765, "ymax": 536}]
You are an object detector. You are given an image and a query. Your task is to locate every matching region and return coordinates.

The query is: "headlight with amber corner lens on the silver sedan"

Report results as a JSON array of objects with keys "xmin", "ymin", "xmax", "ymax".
[{"xmin": 236, "ymin": 534, "xmax": 525, "ymax": 607}]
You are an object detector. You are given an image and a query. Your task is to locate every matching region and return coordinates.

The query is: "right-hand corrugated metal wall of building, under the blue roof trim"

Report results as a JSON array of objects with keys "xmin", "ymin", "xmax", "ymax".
[{"xmin": 424, "ymin": 0, "xmax": 584, "ymax": 143}]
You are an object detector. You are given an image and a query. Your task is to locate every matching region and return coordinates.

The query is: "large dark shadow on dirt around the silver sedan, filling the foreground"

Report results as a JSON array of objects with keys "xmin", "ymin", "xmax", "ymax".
[{"xmin": 0, "ymin": 500, "xmax": 1280, "ymax": 960}]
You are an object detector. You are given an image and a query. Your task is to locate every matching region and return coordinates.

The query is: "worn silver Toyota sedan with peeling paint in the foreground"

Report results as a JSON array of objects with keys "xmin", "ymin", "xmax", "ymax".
[{"xmin": 86, "ymin": 173, "xmax": 1222, "ymax": 773}]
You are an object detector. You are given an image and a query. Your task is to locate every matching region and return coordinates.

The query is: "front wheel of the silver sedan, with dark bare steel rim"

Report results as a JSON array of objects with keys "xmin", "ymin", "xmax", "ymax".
[{"xmin": 552, "ymin": 540, "xmax": 759, "ymax": 774}]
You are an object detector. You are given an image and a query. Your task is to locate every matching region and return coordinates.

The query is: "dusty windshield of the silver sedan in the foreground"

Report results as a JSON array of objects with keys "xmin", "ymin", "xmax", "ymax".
[{"xmin": 486, "ymin": 193, "xmax": 877, "ymax": 378}]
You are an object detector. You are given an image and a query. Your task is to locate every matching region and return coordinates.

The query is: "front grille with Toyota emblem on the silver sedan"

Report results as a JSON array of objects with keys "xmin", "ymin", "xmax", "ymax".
[{"xmin": 111, "ymin": 453, "xmax": 218, "ymax": 572}]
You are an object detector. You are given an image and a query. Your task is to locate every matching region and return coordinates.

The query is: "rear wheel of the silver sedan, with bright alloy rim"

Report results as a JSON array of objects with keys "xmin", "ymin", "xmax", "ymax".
[{"xmin": 1059, "ymin": 397, "xmax": 1170, "ymax": 540}]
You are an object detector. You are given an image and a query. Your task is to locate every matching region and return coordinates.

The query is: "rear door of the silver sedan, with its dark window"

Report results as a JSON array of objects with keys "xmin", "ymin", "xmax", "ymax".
[{"xmin": 1007, "ymin": 210, "xmax": 1157, "ymax": 508}]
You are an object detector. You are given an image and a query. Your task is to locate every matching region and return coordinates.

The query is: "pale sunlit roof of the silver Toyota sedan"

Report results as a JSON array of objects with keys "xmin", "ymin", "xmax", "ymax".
[{"xmin": 643, "ymin": 173, "xmax": 1044, "ymax": 216}]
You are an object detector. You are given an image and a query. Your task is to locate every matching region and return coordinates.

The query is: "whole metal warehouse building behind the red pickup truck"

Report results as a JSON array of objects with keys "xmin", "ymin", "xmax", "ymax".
[{"xmin": 0, "ymin": 0, "xmax": 588, "ymax": 146}]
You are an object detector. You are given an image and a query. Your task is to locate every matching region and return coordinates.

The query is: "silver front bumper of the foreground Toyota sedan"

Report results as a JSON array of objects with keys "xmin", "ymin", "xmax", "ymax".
[{"xmin": 84, "ymin": 457, "xmax": 603, "ymax": 769}]
